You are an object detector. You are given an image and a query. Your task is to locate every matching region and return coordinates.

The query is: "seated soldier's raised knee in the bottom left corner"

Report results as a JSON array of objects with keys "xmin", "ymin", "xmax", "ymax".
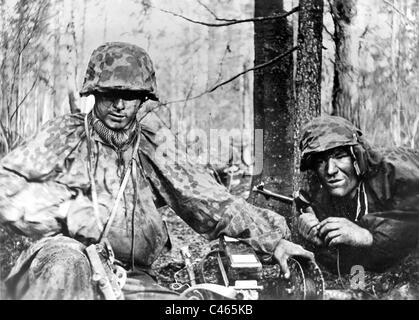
[{"xmin": 8, "ymin": 236, "xmax": 94, "ymax": 300}]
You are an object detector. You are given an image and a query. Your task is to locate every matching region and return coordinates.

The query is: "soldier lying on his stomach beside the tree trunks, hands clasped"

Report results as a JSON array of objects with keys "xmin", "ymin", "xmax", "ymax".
[{"xmin": 298, "ymin": 116, "xmax": 419, "ymax": 272}]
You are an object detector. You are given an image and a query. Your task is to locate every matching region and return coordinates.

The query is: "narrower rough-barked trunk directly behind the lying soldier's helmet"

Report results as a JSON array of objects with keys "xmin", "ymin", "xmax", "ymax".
[{"xmin": 294, "ymin": 0, "xmax": 324, "ymax": 195}]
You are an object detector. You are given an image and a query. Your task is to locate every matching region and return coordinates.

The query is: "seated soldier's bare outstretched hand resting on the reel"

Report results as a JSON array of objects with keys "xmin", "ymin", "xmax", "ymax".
[{"xmin": 274, "ymin": 239, "xmax": 314, "ymax": 279}]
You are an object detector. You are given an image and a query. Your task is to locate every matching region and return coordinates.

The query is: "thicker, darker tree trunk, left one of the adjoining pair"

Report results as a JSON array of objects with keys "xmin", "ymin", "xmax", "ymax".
[{"xmin": 249, "ymin": 0, "xmax": 294, "ymax": 217}]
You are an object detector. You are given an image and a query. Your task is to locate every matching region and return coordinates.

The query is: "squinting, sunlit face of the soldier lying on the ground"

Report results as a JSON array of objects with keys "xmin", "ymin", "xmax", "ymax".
[{"xmin": 313, "ymin": 147, "xmax": 359, "ymax": 197}]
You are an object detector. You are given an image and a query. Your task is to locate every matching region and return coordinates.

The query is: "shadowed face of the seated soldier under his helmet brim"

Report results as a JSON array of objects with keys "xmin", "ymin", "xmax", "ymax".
[{"xmin": 95, "ymin": 94, "xmax": 143, "ymax": 130}]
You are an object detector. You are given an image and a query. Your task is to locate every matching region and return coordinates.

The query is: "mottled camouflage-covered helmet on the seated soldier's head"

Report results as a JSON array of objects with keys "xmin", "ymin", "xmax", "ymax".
[{"xmin": 80, "ymin": 42, "xmax": 158, "ymax": 100}]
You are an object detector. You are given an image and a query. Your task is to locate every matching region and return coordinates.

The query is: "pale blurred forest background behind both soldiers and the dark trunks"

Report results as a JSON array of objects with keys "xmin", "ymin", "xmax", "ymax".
[{"xmin": 0, "ymin": 0, "xmax": 419, "ymax": 300}]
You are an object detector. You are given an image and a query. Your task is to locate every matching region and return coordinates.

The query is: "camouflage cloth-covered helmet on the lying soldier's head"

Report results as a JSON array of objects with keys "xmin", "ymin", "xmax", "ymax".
[{"xmin": 300, "ymin": 115, "xmax": 362, "ymax": 171}]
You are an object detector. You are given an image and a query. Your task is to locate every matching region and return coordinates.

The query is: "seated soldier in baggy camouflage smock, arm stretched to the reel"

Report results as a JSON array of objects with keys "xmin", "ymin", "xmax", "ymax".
[{"xmin": 0, "ymin": 43, "xmax": 313, "ymax": 299}]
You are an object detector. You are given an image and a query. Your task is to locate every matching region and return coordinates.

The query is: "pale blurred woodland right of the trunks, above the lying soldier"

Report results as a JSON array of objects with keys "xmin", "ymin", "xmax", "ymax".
[{"xmin": 323, "ymin": 0, "xmax": 419, "ymax": 148}]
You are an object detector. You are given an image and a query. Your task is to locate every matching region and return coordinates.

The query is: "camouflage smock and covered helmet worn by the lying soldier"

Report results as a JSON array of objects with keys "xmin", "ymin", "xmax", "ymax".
[{"xmin": 301, "ymin": 116, "xmax": 419, "ymax": 271}]
